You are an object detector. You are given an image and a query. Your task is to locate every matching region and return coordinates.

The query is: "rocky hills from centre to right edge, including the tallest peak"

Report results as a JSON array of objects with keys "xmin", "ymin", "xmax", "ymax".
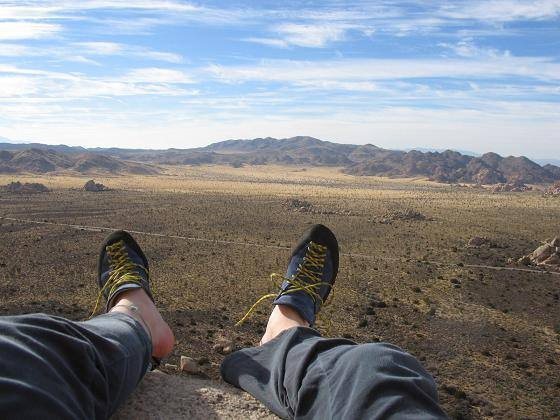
[{"xmin": 199, "ymin": 137, "xmax": 560, "ymax": 184}]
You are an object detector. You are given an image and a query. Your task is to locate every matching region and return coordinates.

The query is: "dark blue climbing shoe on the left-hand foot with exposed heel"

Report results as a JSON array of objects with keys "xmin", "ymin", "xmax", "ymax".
[{"xmin": 94, "ymin": 230, "xmax": 154, "ymax": 313}]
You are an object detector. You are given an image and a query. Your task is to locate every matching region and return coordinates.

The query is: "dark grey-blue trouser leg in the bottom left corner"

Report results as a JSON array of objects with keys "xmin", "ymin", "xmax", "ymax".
[{"xmin": 0, "ymin": 313, "xmax": 152, "ymax": 419}]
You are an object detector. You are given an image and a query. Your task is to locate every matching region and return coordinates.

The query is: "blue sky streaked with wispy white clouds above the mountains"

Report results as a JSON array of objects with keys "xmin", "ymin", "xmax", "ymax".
[{"xmin": 0, "ymin": 0, "xmax": 560, "ymax": 159}]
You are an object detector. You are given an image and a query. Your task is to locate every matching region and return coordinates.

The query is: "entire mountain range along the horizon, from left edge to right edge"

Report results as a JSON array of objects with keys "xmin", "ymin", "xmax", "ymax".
[{"xmin": 0, "ymin": 136, "xmax": 560, "ymax": 184}]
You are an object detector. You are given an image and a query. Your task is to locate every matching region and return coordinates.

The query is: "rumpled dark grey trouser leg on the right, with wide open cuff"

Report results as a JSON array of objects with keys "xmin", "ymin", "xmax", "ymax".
[{"xmin": 221, "ymin": 327, "xmax": 446, "ymax": 419}]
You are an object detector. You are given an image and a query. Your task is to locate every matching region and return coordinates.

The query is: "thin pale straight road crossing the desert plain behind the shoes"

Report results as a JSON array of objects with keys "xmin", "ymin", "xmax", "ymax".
[{"xmin": 0, "ymin": 216, "xmax": 560, "ymax": 276}]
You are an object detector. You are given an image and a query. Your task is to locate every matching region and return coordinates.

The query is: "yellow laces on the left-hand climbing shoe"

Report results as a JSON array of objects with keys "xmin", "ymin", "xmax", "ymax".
[{"xmin": 90, "ymin": 241, "xmax": 148, "ymax": 318}]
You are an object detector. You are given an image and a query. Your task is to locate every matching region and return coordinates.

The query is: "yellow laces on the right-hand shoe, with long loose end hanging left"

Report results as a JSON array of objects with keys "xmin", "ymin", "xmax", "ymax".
[{"xmin": 235, "ymin": 242, "xmax": 332, "ymax": 327}]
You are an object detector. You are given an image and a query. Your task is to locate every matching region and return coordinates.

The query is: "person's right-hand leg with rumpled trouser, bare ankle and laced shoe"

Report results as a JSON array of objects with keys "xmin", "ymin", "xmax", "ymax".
[{"xmin": 221, "ymin": 225, "xmax": 445, "ymax": 419}]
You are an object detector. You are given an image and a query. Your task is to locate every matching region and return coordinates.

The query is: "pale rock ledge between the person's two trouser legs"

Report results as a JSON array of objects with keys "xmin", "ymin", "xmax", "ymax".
[{"xmin": 113, "ymin": 371, "xmax": 278, "ymax": 420}]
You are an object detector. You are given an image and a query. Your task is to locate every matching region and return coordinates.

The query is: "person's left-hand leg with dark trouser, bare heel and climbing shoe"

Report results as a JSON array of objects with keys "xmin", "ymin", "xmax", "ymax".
[{"xmin": 0, "ymin": 232, "xmax": 174, "ymax": 419}]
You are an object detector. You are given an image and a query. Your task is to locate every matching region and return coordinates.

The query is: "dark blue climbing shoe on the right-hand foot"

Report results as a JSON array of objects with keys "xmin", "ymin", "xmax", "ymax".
[{"xmin": 273, "ymin": 225, "xmax": 338, "ymax": 326}]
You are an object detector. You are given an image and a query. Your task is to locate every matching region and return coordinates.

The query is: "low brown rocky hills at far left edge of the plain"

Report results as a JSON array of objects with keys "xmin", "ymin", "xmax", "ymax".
[{"xmin": 0, "ymin": 148, "xmax": 158, "ymax": 174}]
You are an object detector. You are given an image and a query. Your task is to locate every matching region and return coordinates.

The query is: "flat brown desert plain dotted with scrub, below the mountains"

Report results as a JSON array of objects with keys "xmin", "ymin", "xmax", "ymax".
[{"xmin": 0, "ymin": 165, "xmax": 560, "ymax": 419}]
